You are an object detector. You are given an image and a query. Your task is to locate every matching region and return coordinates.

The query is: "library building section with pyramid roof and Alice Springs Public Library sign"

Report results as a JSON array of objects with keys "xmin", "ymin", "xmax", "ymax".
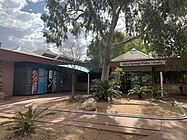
[{"xmin": 111, "ymin": 49, "xmax": 187, "ymax": 94}]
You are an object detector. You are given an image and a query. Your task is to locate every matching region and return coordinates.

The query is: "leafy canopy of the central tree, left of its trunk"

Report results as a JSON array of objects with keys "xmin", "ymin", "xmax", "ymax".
[{"xmin": 41, "ymin": 0, "xmax": 134, "ymax": 38}]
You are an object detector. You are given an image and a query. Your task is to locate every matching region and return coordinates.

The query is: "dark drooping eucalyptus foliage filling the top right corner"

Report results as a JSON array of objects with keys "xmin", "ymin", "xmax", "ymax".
[{"xmin": 140, "ymin": 0, "xmax": 187, "ymax": 57}]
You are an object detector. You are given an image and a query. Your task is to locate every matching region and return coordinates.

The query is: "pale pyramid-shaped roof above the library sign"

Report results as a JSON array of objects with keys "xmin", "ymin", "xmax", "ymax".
[{"xmin": 111, "ymin": 48, "xmax": 153, "ymax": 62}]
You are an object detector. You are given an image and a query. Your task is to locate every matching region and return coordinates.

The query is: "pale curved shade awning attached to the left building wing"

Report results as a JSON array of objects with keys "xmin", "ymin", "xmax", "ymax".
[{"xmin": 58, "ymin": 64, "xmax": 92, "ymax": 73}]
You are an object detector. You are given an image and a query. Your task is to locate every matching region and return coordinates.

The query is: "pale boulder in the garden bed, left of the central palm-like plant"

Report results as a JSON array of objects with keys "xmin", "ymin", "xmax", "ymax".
[{"xmin": 81, "ymin": 98, "xmax": 96, "ymax": 111}]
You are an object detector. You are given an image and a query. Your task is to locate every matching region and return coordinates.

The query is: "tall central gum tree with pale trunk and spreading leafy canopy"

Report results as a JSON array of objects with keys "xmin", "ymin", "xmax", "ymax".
[{"xmin": 42, "ymin": 0, "xmax": 140, "ymax": 80}]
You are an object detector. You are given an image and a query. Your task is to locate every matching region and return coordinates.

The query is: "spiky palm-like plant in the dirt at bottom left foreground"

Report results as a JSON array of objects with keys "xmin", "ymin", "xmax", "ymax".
[{"xmin": 2, "ymin": 106, "xmax": 52, "ymax": 136}]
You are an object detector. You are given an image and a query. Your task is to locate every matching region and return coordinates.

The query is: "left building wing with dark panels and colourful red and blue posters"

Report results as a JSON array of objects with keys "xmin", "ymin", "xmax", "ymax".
[{"xmin": 0, "ymin": 47, "xmax": 91, "ymax": 97}]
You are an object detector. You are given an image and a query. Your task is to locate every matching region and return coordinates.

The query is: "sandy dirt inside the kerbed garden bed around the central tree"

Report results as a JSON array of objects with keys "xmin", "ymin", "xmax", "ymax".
[{"xmin": 40, "ymin": 96, "xmax": 182, "ymax": 116}]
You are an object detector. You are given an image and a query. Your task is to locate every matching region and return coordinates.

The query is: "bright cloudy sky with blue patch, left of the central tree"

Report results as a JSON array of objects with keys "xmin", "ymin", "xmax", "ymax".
[{"xmin": 0, "ymin": 0, "xmax": 125, "ymax": 56}]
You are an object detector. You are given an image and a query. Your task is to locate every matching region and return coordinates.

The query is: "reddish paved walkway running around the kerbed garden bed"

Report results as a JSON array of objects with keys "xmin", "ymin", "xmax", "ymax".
[{"xmin": 0, "ymin": 94, "xmax": 187, "ymax": 140}]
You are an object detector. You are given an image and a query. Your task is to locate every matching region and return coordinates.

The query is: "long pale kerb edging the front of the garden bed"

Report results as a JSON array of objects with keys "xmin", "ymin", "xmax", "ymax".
[{"xmin": 38, "ymin": 101, "xmax": 187, "ymax": 120}]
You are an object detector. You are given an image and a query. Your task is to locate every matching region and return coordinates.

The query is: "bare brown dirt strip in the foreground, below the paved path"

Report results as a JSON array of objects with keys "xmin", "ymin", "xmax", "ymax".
[{"xmin": 0, "ymin": 124, "xmax": 143, "ymax": 140}]
